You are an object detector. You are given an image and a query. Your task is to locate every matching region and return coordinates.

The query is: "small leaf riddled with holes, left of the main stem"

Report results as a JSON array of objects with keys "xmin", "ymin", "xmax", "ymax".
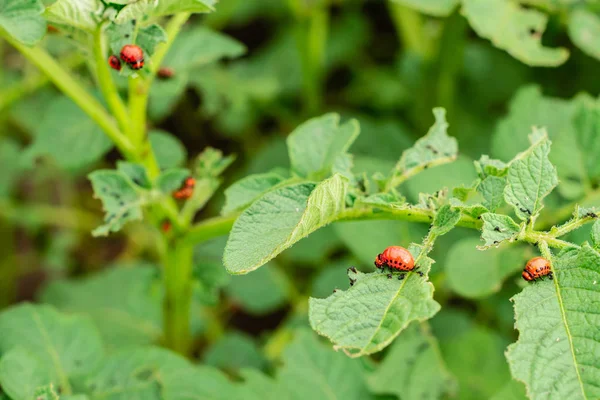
[{"xmin": 89, "ymin": 170, "xmax": 148, "ymax": 236}]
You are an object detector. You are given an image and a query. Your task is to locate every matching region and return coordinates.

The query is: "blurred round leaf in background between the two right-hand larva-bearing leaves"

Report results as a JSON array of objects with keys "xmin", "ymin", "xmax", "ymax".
[{"xmin": 445, "ymin": 238, "xmax": 524, "ymax": 299}]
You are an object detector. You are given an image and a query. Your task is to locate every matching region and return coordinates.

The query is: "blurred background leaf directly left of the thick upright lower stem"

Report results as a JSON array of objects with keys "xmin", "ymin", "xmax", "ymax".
[{"xmin": 41, "ymin": 264, "xmax": 162, "ymax": 348}]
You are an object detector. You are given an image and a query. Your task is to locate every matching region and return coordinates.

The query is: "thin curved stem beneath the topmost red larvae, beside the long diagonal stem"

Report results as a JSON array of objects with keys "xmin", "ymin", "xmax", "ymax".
[{"xmin": 94, "ymin": 24, "xmax": 130, "ymax": 137}]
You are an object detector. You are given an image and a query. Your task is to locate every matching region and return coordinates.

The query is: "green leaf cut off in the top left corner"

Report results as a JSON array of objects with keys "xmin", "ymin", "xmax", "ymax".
[{"xmin": 0, "ymin": 0, "xmax": 46, "ymax": 46}]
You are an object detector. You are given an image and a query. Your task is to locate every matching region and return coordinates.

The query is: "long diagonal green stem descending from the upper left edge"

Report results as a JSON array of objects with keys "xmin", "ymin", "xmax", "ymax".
[{"xmin": 2, "ymin": 34, "xmax": 136, "ymax": 159}]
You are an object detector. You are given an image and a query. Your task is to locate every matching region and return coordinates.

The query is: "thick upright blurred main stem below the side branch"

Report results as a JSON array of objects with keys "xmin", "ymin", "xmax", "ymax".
[{"xmin": 163, "ymin": 240, "xmax": 194, "ymax": 355}]
